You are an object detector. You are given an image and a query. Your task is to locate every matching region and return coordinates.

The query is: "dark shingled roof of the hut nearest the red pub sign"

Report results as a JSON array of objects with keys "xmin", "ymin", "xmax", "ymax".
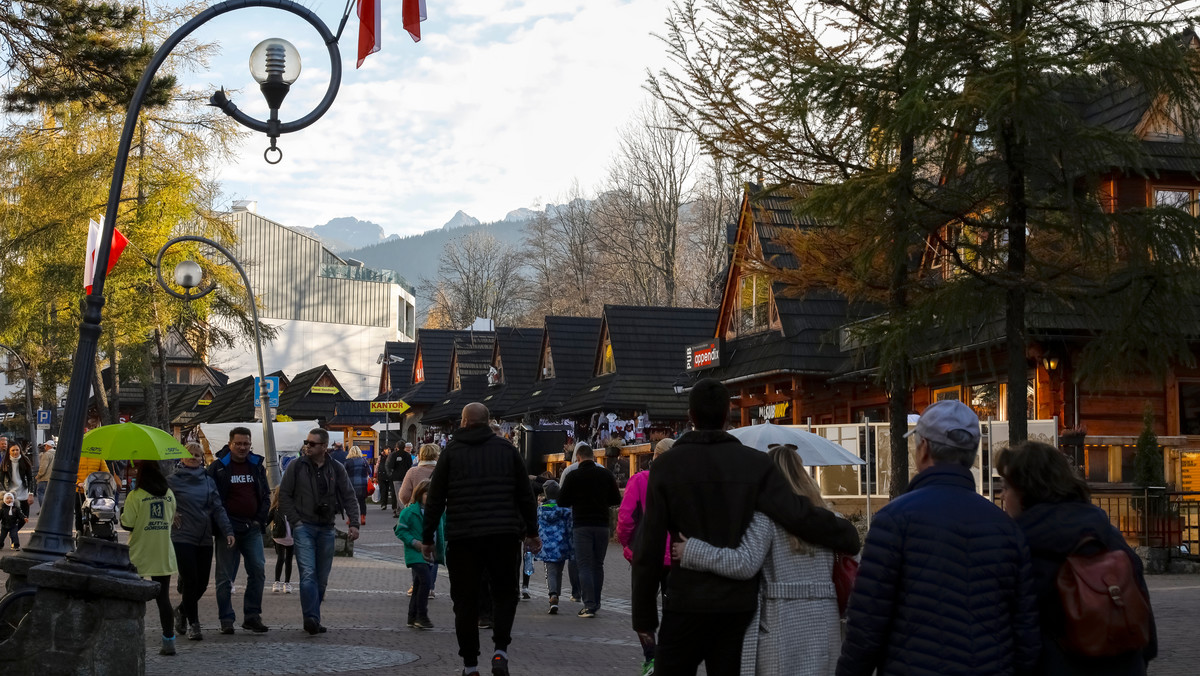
[{"xmin": 556, "ymin": 305, "xmax": 718, "ymax": 421}]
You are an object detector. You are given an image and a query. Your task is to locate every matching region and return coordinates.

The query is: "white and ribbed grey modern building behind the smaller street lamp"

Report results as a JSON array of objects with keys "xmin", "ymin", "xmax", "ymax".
[{"xmin": 208, "ymin": 202, "xmax": 416, "ymax": 400}]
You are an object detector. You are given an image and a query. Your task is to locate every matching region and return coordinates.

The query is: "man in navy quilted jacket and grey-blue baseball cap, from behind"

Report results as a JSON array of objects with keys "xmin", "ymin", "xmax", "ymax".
[{"xmin": 838, "ymin": 401, "xmax": 1040, "ymax": 676}]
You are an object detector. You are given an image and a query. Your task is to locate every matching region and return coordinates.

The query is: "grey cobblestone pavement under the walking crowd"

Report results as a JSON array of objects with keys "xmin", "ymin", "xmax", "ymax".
[{"xmin": 0, "ymin": 504, "xmax": 1200, "ymax": 676}]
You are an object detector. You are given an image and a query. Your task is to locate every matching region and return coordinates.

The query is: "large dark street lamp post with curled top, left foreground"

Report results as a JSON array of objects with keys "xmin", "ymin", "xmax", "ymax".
[{"xmin": 0, "ymin": 0, "xmax": 348, "ymax": 576}]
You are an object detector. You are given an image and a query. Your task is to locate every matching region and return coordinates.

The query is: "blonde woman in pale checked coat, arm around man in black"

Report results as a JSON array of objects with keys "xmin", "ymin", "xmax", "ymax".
[{"xmin": 671, "ymin": 445, "xmax": 841, "ymax": 676}]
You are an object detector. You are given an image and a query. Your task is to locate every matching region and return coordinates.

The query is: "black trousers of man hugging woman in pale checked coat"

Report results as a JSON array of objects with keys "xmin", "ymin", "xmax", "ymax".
[{"xmin": 654, "ymin": 610, "xmax": 754, "ymax": 676}]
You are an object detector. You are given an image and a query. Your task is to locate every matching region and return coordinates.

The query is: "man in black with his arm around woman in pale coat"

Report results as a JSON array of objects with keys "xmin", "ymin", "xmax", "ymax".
[{"xmin": 632, "ymin": 378, "xmax": 859, "ymax": 676}]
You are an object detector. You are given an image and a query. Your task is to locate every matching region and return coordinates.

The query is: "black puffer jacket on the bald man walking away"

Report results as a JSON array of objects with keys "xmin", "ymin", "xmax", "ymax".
[{"xmin": 421, "ymin": 425, "xmax": 538, "ymax": 544}]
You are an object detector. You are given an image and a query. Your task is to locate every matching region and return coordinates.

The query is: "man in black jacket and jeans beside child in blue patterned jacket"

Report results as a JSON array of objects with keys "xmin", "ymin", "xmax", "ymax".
[{"xmin": 558, "ymin": 444, "xmax": 620, "ymax": 617}]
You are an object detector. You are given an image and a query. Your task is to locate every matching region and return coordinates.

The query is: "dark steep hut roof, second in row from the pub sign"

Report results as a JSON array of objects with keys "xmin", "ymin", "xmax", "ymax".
[{"xmin": 504, "ymin": 317, "xmax": 600, "ymax": 418}]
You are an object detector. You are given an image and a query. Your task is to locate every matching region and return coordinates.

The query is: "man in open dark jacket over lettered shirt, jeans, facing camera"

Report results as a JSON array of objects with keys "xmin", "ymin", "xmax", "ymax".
[{"xmin": 209, "ymin": 427, "xmax": 271, "ymax": 634}]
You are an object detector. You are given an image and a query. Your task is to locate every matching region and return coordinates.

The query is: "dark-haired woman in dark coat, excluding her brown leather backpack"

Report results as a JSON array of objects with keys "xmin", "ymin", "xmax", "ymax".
[{"xmin": 996, "ymin": 442, "xmax": 1158, "ymax": 676}]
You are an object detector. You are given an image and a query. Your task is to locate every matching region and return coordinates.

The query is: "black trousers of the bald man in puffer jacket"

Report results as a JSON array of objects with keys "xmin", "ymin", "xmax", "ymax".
[{"xmin": 446, "ymin": 534, "xmax": 521, "ymax": 666}]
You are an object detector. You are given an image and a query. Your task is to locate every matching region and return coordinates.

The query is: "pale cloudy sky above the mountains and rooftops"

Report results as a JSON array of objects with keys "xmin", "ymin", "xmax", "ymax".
[{"xmin": 178, "ymin": 0, "xmax": 668, "ymax": 234}]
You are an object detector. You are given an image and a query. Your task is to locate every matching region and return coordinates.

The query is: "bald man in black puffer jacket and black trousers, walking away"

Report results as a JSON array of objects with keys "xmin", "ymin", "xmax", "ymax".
[{"xmin": 420, "ymin": 403, "xmax": 541, "ymax": 676}]
